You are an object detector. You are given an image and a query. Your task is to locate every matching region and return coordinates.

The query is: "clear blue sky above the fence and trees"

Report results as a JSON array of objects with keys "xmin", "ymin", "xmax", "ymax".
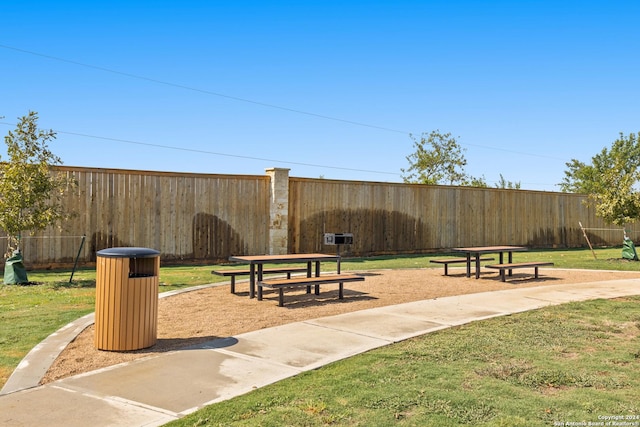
[{"xmin": 0, "ymin": 0, "xmax": 640, "ymax": 191}]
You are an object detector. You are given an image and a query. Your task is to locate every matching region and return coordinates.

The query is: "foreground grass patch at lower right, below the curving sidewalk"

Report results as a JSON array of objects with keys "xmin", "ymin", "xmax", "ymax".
[{"xmin": 168, "ymin": 296, "xmax": 640, "ymax": 427}]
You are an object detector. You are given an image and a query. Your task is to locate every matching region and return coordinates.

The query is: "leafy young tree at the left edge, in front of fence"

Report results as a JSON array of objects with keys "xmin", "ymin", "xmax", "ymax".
[{"xmin": 0, "ymin": 111, "xmax": 75, "ymax": 280}]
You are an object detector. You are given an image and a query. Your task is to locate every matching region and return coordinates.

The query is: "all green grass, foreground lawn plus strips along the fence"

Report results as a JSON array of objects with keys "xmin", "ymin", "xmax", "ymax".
[{"xmin": 0, "ymin": 248, "xmax": 640, "ymax": 426}]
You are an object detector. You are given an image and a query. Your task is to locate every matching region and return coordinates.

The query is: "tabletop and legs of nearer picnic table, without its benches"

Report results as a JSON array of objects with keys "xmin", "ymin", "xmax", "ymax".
[{"xmin": 229, "ymin": 254, "xmax": 340, "ymax": 298}]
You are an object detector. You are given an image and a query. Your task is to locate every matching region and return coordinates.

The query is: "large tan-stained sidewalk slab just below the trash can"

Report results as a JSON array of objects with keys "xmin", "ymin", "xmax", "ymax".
[{"xmin": 58, "ymin": 350, "xmax": 299, "ymax": 416}]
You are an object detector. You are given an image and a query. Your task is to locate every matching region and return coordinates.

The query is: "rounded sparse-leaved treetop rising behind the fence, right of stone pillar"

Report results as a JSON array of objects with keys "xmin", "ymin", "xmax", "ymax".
[{"xmin": 401, "ymin": 130, "xmax": 487, "ymax": 187}]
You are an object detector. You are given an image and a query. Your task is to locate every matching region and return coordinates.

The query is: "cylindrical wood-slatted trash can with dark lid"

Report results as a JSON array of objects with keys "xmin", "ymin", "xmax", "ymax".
[{"xmin": 95, "ymin": 247, "xmax": 160, "ymax": 351}]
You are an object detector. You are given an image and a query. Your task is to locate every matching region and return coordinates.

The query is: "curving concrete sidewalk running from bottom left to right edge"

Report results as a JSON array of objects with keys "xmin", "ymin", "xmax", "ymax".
[{"xmin": 0, "ymin": 279, "xmax": 640, "ymax": 427}]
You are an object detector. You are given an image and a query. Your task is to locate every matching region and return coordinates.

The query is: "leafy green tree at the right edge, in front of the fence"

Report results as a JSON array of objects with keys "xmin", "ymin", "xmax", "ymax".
[{"xmin": 560, "ymin": 132, "xmax": 640, "ymax": 227}]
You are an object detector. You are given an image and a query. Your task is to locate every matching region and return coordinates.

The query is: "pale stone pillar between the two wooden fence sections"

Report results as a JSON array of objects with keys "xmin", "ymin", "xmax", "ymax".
[{"xmin": 266, "ymin": 168, "xmax": 290, "ymax": 255}]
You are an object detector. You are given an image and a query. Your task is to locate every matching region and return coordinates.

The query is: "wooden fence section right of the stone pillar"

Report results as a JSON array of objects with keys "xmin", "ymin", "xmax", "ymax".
[{"xmin": 289, "ymin": 178, "xmax": 623, "ymax": 256}]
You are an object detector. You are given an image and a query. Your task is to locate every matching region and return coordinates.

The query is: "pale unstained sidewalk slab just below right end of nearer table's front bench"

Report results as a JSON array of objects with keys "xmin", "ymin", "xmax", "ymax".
[{"xmin": 305, "ymin": 310, "xmax": 449, "ymax": 342}]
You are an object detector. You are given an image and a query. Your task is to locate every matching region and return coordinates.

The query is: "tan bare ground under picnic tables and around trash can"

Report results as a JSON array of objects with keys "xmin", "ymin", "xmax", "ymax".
[{"xmin": 42, "ymin": 268, "xmax": 640, "ymax": 384}]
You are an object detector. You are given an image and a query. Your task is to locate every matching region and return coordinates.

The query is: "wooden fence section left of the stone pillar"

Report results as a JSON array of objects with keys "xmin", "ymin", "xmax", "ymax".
[{"xmin": 0, "ymin": 167, "xmax": 269, "ymax": 266}]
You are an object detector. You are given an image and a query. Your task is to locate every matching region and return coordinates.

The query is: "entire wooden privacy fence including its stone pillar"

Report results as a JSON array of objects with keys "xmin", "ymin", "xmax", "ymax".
[{"xmin": 0, "ymin": 167, "xmax": 634, "ymax": 267}]
